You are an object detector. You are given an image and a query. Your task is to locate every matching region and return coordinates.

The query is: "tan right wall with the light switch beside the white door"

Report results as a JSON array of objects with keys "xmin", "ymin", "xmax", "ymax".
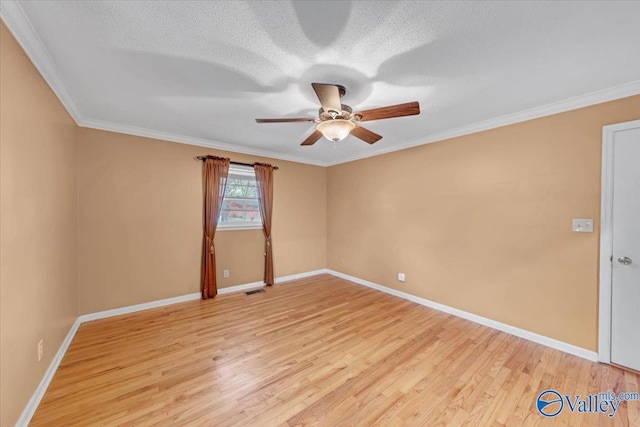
[{"xmin": 327, "ymin": 96, "xmax": 640, "ymax": 350}]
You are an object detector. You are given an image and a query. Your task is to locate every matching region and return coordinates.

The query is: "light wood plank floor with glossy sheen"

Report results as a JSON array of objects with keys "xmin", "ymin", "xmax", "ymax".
[{"xmin": 31, "ymin": 275, "xmax": 640, "ymax": 426}]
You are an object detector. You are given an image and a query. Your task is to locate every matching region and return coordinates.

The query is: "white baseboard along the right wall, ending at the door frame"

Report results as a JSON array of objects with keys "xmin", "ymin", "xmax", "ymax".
[{"xmin": 327, "ymin": 269, "xmax": 598, "ymax": 362}]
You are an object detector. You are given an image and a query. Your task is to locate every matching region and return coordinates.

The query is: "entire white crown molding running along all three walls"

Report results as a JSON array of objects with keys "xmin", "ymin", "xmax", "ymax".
[{"xmin": 0, "ymin": 0, "xmax": 640, "ymax": 167}]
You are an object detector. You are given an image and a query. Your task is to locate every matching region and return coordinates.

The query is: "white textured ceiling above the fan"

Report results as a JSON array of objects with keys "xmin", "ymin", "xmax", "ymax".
[{"xmin": 2, "ymin": 1, "xmax": 640, "ymax": 165}]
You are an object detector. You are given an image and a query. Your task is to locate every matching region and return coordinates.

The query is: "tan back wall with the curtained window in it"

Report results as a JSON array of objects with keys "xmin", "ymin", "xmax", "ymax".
[{"xmin": 78, "ymin": 128, "xmax": 327, "ymax": 314}]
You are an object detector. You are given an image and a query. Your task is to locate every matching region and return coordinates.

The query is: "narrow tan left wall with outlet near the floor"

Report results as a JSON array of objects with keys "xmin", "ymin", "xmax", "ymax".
[{"xmin": 0, "ymin": 23, "xmax": 78, "ymax": 426}]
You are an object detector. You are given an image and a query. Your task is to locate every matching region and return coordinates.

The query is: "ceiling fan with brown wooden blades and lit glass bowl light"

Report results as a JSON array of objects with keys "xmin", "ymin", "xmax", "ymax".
[{"xmin": 256, "ymin": 83, "xmax": 420, "ymax": 145}]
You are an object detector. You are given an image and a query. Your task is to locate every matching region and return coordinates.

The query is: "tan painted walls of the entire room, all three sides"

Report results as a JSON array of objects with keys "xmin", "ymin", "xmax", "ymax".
[{"xmin": 0, "ymin": 10, "xmax": 640, "ymax": 426}]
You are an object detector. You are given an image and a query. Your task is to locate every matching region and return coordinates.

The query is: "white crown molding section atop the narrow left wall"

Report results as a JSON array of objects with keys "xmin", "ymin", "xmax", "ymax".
[{"xmin": 0, "ymin": 0, "xmax": 82, "ymax": 124}]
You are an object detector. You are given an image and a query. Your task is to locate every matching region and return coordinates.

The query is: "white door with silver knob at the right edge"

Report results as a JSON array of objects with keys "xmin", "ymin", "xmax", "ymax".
[{"xmin": 611, "ymin": 124, "xmax": 640, "ymax": 371}]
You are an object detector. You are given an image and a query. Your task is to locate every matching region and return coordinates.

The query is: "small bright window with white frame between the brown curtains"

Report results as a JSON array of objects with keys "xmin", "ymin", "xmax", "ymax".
[{"xmin": 218, "ymin": 165, "xmax": 262, "ymax": 230}]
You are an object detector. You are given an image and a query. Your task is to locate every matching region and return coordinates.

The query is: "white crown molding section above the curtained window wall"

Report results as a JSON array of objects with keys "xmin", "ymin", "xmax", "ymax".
[{"xmin": 79, "ymin": 119, "xmax": 328, "ymax": 167}]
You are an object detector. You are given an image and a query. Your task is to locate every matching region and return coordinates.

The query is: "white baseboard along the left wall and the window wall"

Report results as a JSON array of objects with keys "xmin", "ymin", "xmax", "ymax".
[{"xmin": 16, "ymin": 268, "xmax": 327, "ymax": 427}]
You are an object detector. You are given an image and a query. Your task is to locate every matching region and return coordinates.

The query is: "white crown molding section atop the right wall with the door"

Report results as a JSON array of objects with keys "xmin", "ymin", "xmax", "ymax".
[{"xmin": 328, "ymin": 80, "xmax": 640, "ymax": 166}]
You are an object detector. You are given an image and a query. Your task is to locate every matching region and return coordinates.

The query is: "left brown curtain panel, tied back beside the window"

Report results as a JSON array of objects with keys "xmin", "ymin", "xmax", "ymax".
[{"xmin": 202, "ymin": 156, "xmax": 229, "ymax": 299}]
